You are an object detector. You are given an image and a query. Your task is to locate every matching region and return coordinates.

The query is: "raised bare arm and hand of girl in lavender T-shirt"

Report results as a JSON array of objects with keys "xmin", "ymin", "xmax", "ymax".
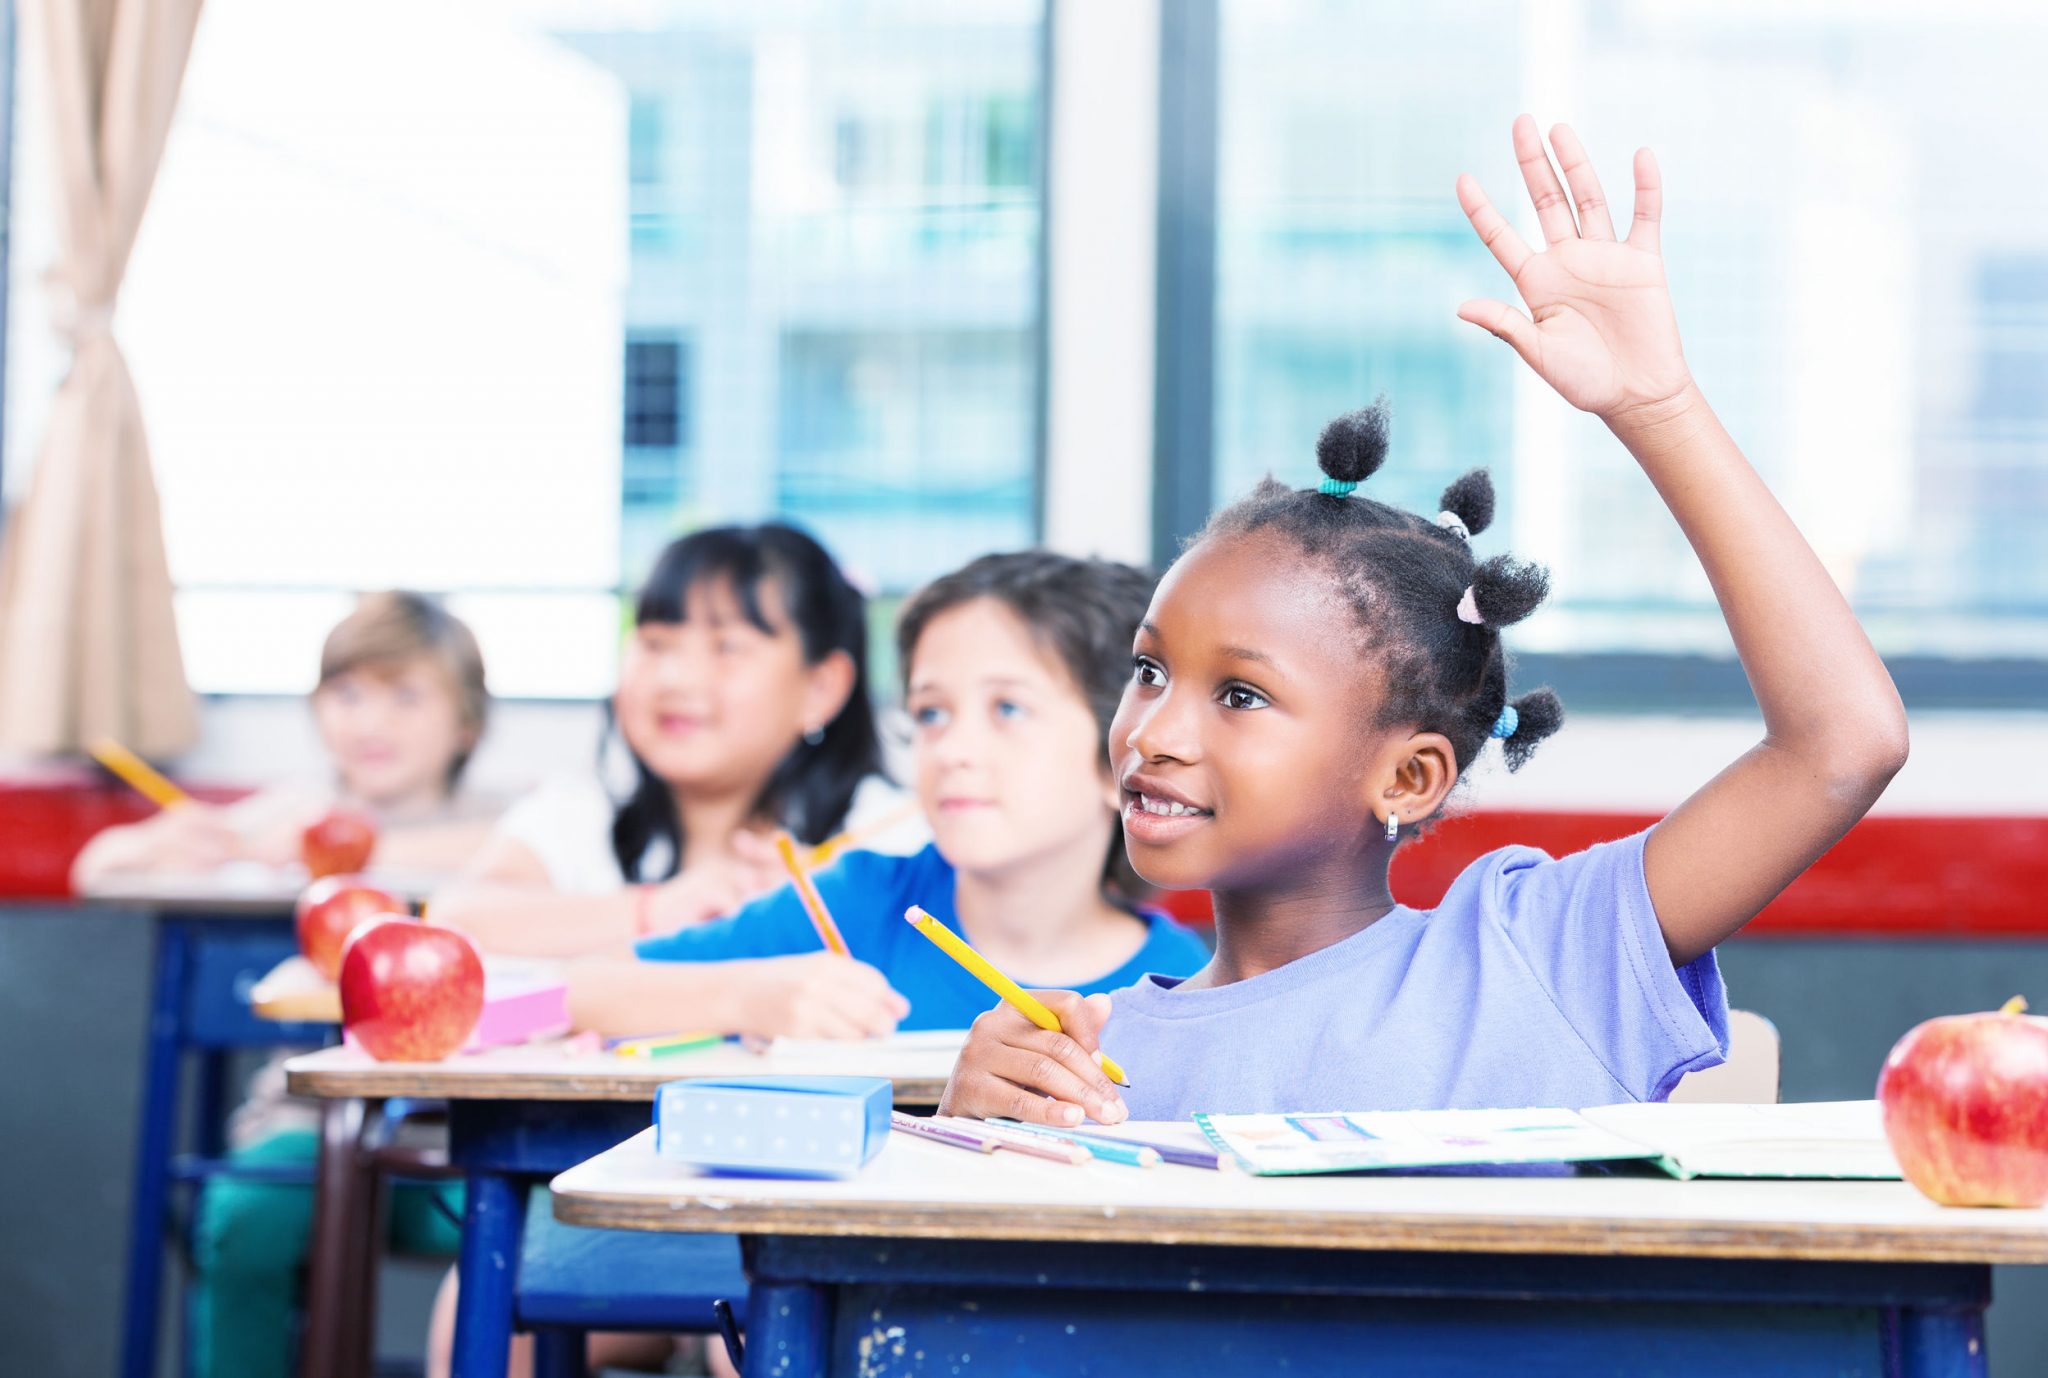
[{"xmin": 1458, "ymin": 115, "xmax": 1907, "ymax": 964}]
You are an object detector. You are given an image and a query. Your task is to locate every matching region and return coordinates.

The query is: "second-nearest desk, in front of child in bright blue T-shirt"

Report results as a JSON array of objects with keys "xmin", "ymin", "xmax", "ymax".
[{"xmin": 287, "ymin": 1034, "xmax": 961, "ymax": 1378}]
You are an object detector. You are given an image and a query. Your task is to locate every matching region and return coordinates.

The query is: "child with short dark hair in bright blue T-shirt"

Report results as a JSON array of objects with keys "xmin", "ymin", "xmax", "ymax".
[{"xmin": 569, "ymin": 551, "xmax": 1208, "ymax": 1036}]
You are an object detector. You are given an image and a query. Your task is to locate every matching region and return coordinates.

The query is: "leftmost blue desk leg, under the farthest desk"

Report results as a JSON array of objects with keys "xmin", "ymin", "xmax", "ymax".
[{"xmin": 121, "ymin": 919, "xmax": 190, "ymax": 1378}]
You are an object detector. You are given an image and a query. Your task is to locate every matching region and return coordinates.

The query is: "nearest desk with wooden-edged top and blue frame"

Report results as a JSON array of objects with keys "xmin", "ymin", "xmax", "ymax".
[{"xmin": 553, "ymin": 1132, "xmax": 2048, "ymax": 1378}]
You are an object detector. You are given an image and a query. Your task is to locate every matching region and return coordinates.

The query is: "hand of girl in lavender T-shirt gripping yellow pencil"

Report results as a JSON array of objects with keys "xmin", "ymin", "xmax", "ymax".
[{"xmin": 938, "ymin": 991, "xmax": 1130, "ymax": 1128}]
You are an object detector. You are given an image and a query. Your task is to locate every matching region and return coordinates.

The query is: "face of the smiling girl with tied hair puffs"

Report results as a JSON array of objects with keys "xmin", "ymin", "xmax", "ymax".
[{"xmin": 1110, "ymin": 532, "xmax": 1391, "ymax": 891}]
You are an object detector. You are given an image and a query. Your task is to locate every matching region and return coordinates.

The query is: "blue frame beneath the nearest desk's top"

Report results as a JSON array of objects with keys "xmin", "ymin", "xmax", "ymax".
[{"xmin": 741, "ymin": 1235, "xmax": 1991, "ymax": 1378}]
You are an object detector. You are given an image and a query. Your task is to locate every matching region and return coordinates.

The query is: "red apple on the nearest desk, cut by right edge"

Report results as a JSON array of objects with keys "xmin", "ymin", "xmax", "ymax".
[{"xmin": 1878, "ymin": 995, "xmax": 2048, "ymax": 1206}]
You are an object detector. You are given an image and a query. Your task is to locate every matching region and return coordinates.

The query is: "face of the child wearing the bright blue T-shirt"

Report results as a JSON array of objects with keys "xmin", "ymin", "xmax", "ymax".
[{"xmin": 905, "ymin": 598, "xmax": 1116, "ymax": 874}]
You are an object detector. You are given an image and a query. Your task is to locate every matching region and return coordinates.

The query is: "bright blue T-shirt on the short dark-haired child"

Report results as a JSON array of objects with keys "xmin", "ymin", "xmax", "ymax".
[{"xmin": 635, "ymin": 846, "xmax": 1208, "ymax": 1032}]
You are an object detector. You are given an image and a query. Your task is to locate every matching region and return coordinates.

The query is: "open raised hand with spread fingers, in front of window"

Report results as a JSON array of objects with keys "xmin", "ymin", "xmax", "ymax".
[{"xmin": 1458, "ymin": 115, "xmax": 1692, "ymax": 420}]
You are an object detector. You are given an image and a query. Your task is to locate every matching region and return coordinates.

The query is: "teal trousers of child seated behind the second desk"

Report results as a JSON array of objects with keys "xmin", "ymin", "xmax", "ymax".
[{"xmin": 188, "ymin": 1130, "xmax": 463, "ymax": 1378}]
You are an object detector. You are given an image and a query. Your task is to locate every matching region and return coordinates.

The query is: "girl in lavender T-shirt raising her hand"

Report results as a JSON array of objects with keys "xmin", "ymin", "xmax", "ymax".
[{"xmin": 942, "ymin": 117, "xmax": 1907, "ymax": 1124}]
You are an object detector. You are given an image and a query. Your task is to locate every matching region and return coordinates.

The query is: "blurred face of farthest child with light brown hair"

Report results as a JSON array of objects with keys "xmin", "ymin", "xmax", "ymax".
[{"xmin": 313, "ymin": 655, "xmax": 475, "ymax": 809}]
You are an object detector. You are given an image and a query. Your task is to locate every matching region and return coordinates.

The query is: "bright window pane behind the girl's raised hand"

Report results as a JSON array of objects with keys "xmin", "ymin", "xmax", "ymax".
[{"xmin": 1208, "ymin": 0, "xmax": 2048, "ymax": 679}]
